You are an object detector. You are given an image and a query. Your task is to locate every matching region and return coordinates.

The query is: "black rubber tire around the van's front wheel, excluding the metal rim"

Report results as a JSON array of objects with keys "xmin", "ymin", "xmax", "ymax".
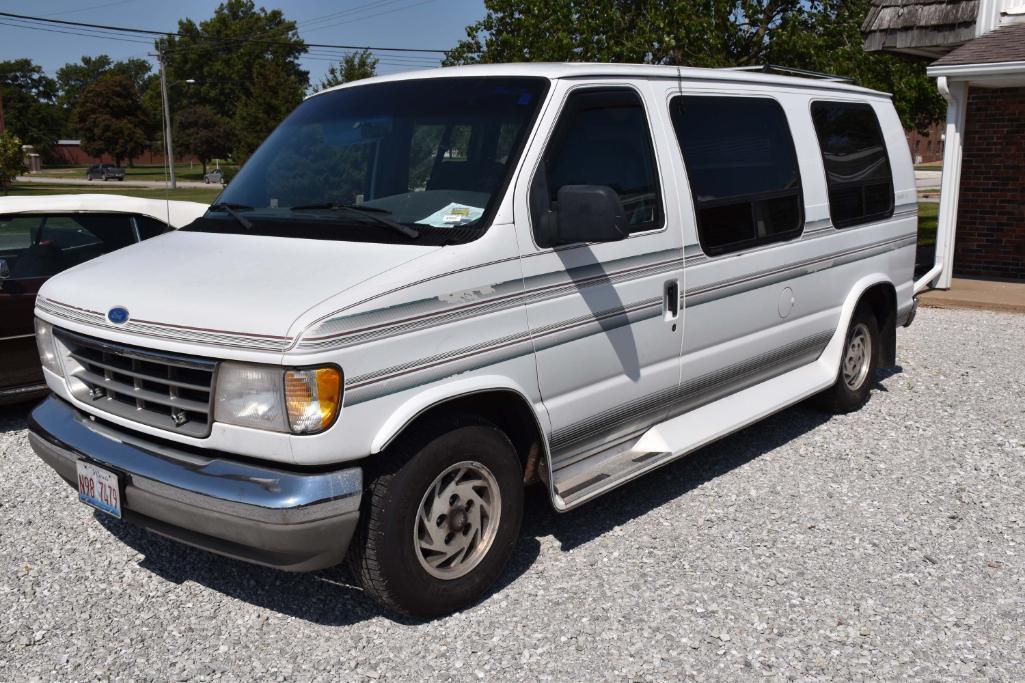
[{"xmin": 347, "ymin": 416, "xmax": 523, "ymax": 618}]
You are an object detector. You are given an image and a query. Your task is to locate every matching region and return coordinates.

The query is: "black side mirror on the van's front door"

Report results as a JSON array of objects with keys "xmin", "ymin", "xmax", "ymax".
[{"xmin": 549, "ymin": 185, "xmax": 629, "ymax": 246}]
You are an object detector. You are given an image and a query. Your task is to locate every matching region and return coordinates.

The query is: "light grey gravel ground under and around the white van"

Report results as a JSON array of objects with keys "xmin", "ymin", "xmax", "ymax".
[{"xmin": 0, "ymin": 309, "xmax": 1025, "ymax": 681}]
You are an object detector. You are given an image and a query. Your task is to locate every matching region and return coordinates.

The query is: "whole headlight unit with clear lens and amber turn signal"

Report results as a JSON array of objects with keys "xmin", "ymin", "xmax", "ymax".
[{"xmin": 213, "ymin": 362, "xmax": 341, "ymax": 434}]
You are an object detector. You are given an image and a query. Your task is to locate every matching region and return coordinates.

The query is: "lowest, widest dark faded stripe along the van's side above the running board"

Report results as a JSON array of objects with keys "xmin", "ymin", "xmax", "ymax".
[{"xmin": 550, "ymin": 331, "xmax": 833, "ymax": 469}]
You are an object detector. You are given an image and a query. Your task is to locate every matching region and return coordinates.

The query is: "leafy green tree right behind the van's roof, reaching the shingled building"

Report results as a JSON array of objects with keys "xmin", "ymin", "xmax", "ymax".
[{"xmin": 445, "ymin": 0, "xmax": 943, "ymax": 127}]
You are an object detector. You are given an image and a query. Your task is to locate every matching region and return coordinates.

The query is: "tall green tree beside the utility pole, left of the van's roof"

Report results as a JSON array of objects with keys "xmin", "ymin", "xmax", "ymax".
[{"xmin": 157, "ymin": 0, "xmax": 310, "ymax": 157}]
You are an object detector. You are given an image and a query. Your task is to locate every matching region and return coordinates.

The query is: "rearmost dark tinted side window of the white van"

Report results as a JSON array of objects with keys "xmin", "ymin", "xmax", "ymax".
[{"xmin": 812, "ymin": 102, "xmax": 894, "ymax": 228}]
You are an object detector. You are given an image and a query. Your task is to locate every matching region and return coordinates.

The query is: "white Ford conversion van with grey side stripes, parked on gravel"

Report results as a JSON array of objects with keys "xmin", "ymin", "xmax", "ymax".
[{"xmin": 30, "ymin": 65, "xmax": 916, "ymax": 616}]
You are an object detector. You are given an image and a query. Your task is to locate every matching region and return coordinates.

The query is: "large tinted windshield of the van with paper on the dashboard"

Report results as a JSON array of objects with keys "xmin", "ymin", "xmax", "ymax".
[{"xmin": 196, "ymin": 77, "xmax": 547, "ymax": 244}]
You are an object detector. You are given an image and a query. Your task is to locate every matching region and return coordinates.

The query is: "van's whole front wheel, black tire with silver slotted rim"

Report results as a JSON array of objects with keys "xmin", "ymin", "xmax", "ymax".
[{"xmin": 349, "ymin": 417, "xmax": 523, "ymax": 618}]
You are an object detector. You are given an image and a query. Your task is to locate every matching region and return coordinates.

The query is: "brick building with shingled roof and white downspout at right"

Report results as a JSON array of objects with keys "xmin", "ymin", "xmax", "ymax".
[{"xmin": 862, "ymin": 0, "xmax": 1025, "ymax": 280}]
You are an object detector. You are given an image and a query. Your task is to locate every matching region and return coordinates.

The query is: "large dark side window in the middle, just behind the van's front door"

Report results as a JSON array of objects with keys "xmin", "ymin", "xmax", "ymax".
[{"xmin": 670, "ymin": 95, "xmax": 804, "ymax": 255}]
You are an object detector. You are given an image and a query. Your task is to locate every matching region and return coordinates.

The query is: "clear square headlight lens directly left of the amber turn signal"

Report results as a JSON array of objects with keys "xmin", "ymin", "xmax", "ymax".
[{"xmin": 213, "ymin": 363, "xmax": 288, "ymax": 432}]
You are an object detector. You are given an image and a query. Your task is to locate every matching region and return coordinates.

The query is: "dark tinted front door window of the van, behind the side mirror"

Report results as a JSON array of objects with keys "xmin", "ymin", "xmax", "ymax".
[{"xmin": 535, "ymin": 90, "xmax": 662, "ymax": 233}]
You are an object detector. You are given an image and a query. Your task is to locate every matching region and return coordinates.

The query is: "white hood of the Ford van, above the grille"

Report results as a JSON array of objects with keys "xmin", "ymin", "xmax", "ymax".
[{"xmin": 37, "ymin": 232, "xmax": 439, "ymax": 351}]
